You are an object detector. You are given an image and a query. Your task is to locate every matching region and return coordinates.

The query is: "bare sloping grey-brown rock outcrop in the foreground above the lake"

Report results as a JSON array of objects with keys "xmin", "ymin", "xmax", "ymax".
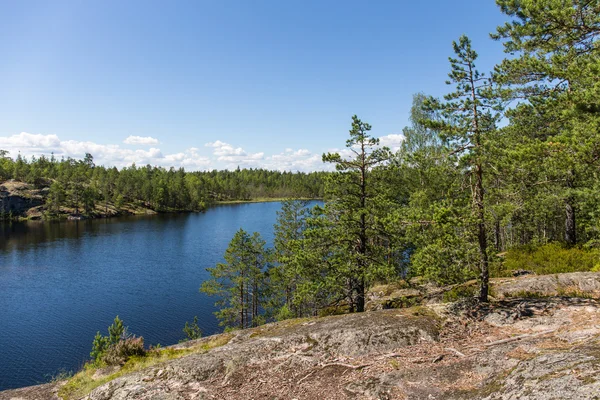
[{"xmin": 0, "ymin": 274, "xmax": 600, "ymax": 400}]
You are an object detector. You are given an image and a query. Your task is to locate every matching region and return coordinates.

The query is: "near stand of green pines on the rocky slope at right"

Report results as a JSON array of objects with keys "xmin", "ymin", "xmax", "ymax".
[{"xmin": 202, "ymin": 0, "xmax": 600, "ymax": 328}]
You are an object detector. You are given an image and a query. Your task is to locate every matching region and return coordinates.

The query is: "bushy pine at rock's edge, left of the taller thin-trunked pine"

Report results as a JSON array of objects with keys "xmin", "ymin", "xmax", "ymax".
[{"xmin": 312, "ymin": 115, "xmax": 396, "ymax": 312}]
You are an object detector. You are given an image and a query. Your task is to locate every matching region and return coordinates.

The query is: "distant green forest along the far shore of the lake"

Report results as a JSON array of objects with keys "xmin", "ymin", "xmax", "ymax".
[{"xmin": 0, "ymin": 150, "xmax": 326, "ymax": 215}]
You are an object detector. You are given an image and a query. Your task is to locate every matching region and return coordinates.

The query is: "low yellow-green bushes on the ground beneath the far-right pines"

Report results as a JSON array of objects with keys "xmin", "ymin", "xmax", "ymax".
[{"xmin": 492, "ymin": 243, "xmax": 600, "ymax": 276}]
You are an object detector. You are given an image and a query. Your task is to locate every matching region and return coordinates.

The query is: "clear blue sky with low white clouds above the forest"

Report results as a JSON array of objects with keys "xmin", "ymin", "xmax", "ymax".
[{"xmin": 0, "ymin": 0, "xmax": 506, "ymax": 171}]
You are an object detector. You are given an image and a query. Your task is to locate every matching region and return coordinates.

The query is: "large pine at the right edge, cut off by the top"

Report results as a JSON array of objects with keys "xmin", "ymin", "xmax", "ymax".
[{"xmin": 491, "ymin": 0, "xmax": 600, "ymax": 245}]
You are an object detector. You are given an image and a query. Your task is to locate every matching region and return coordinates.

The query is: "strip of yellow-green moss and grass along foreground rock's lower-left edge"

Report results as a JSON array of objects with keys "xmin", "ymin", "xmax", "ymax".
[{"xmin": 58, "ymin": 334, "xmax": 233, "ymax": 400}]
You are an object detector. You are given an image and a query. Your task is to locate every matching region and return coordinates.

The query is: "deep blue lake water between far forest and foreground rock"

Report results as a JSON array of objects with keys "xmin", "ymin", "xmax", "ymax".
[{"xmin": 0, "ymin": 203, "xmax": 318, "ymax": 390}]
